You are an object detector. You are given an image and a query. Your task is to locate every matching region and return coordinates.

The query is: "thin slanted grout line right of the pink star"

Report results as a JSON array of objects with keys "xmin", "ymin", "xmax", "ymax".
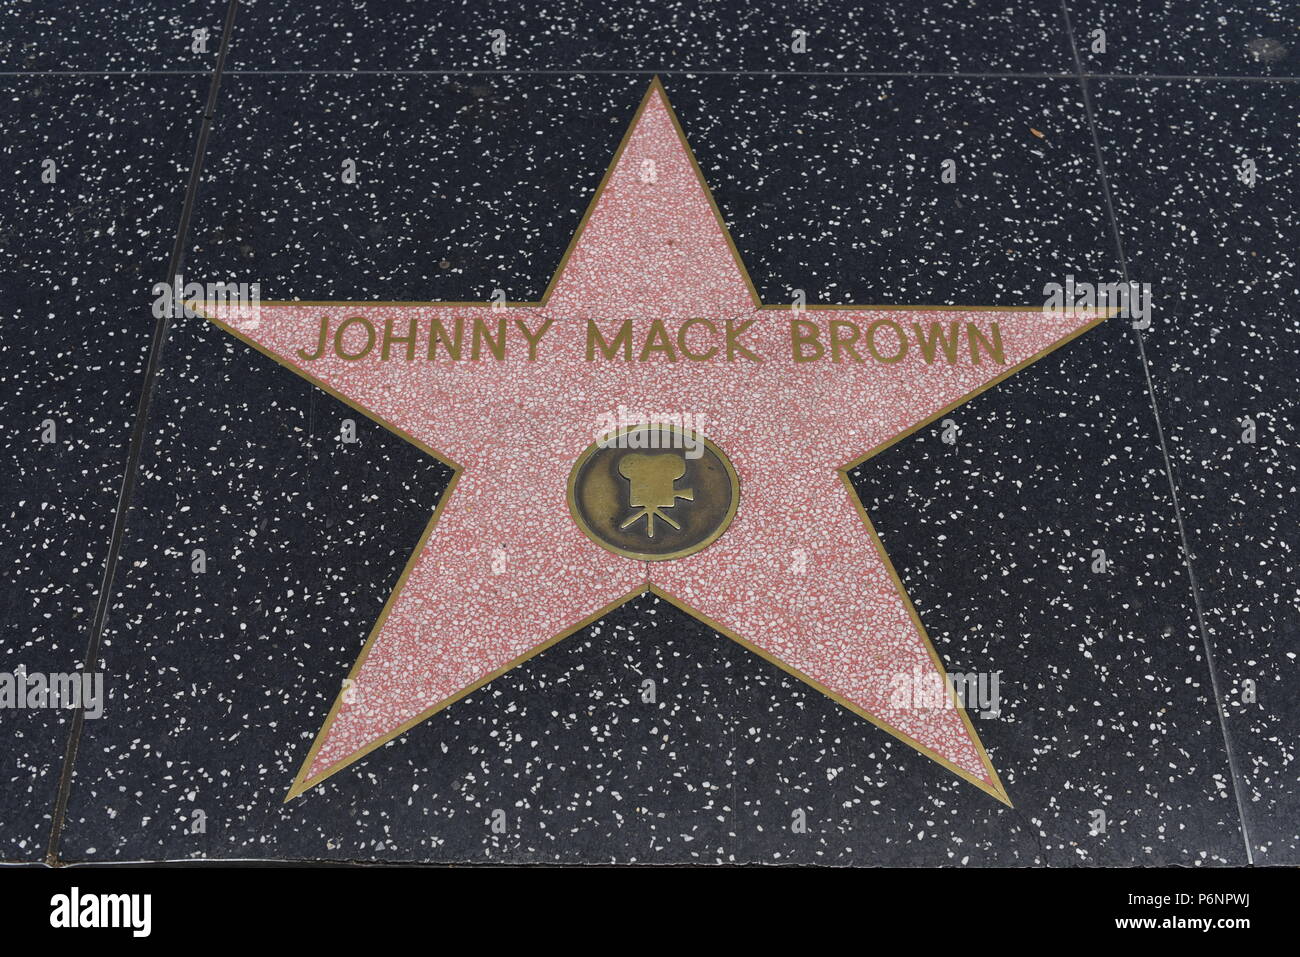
[{"xmin": 1061, "ymin": 0, "xmax": 1255, "ymax": 865}]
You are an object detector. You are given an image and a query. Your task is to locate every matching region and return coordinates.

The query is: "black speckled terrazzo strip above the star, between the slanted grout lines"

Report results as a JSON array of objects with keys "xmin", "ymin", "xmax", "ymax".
[{"xmin": 231, "ymin": 0, "xmax": 1070, "ymax": 73}]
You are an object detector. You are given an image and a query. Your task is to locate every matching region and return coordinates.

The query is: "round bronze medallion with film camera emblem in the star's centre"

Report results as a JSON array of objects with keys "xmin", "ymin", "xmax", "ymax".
[{"xmin": 568, "ymin": 424, "xmax": 740, "ymax": 562}]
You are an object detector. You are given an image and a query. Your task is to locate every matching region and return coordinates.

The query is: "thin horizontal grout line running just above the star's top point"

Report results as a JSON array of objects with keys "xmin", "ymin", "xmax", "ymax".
[{"xmin": 0, "ymin": 67, "xmax": 1300, "ymax": 83}]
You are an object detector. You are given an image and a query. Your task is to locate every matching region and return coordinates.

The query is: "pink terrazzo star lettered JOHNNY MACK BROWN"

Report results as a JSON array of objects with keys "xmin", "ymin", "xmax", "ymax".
[{"xmin": 202, "ymin": 81, "xmax": 1099, "ymax": 804}]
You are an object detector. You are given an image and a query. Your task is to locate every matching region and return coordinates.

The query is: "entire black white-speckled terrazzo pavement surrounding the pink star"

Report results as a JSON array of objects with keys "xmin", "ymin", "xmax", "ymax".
[{"xmin": 0, "ymin": 0, "xmax": 1300, "ymax": 866}]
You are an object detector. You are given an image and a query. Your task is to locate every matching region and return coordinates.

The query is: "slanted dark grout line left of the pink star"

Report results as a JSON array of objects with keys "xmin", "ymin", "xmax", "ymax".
[{"xmin": 46, "ymin": 0, "xmax": 239, "ymax": 867}]
